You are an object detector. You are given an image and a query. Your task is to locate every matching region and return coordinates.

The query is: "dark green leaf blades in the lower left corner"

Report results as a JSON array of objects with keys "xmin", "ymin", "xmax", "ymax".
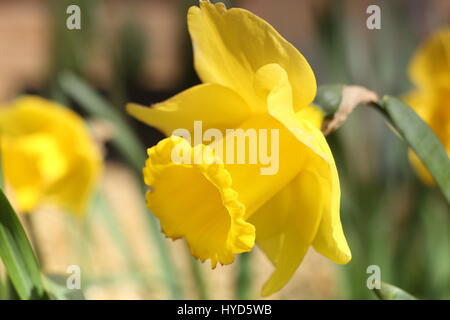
[{"xmin": 0, "ymin": 190, "xmax": 48, "ymax": 299}]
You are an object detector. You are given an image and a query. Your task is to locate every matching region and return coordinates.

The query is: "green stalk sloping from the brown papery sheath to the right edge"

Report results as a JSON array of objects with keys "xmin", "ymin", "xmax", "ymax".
[{"xmin": 380, "ymin": 96, "xmax": 450, "ymax": 203}]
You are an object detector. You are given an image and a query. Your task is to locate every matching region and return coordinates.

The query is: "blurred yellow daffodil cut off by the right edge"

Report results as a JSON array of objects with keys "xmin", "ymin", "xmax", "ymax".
[{"xmin": 405, "ymin": 28, "xmax": 450, "ymax": 185}]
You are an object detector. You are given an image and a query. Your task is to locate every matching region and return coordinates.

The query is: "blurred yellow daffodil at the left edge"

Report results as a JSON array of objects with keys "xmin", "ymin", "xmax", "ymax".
[{"xmin": 0, "ymin": 96, "xmax": 102, "ymax": 215}]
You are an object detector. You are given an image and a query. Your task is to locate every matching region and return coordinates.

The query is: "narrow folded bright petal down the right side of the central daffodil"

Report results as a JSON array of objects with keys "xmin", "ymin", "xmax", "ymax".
[{"xmin": 248, "ymin": 64, "xmax": 351, "ymax": 263}]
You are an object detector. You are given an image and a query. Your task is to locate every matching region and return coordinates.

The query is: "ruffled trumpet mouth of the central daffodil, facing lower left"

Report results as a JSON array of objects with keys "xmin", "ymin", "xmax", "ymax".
[{"xmin": 143, "ymin": 136, "xmax": 255, "ymax": 268}]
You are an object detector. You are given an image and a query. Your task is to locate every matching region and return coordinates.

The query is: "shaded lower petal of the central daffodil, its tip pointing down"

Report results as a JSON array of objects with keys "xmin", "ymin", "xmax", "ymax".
[{"xmin": 249, "ymin": 170, "xmax": 323, "ymax": 296}]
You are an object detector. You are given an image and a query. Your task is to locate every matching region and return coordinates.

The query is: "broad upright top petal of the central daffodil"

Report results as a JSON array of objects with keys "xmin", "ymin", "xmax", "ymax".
[{"xmin": 188, "ymin": 1, "xmax": 316, "ymax": 111}]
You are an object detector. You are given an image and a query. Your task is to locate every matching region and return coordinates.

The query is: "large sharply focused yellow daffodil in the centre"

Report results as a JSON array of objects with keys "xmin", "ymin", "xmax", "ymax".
[{"xmin": 127, "ymin": 1, "xmax": 351, "ymax": 296}]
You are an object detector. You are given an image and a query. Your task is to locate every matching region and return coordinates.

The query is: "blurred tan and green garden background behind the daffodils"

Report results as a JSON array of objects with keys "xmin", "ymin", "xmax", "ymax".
[{"xmin": 0, "ymin": 0, "xmax": 450, "ymax": 299}]
